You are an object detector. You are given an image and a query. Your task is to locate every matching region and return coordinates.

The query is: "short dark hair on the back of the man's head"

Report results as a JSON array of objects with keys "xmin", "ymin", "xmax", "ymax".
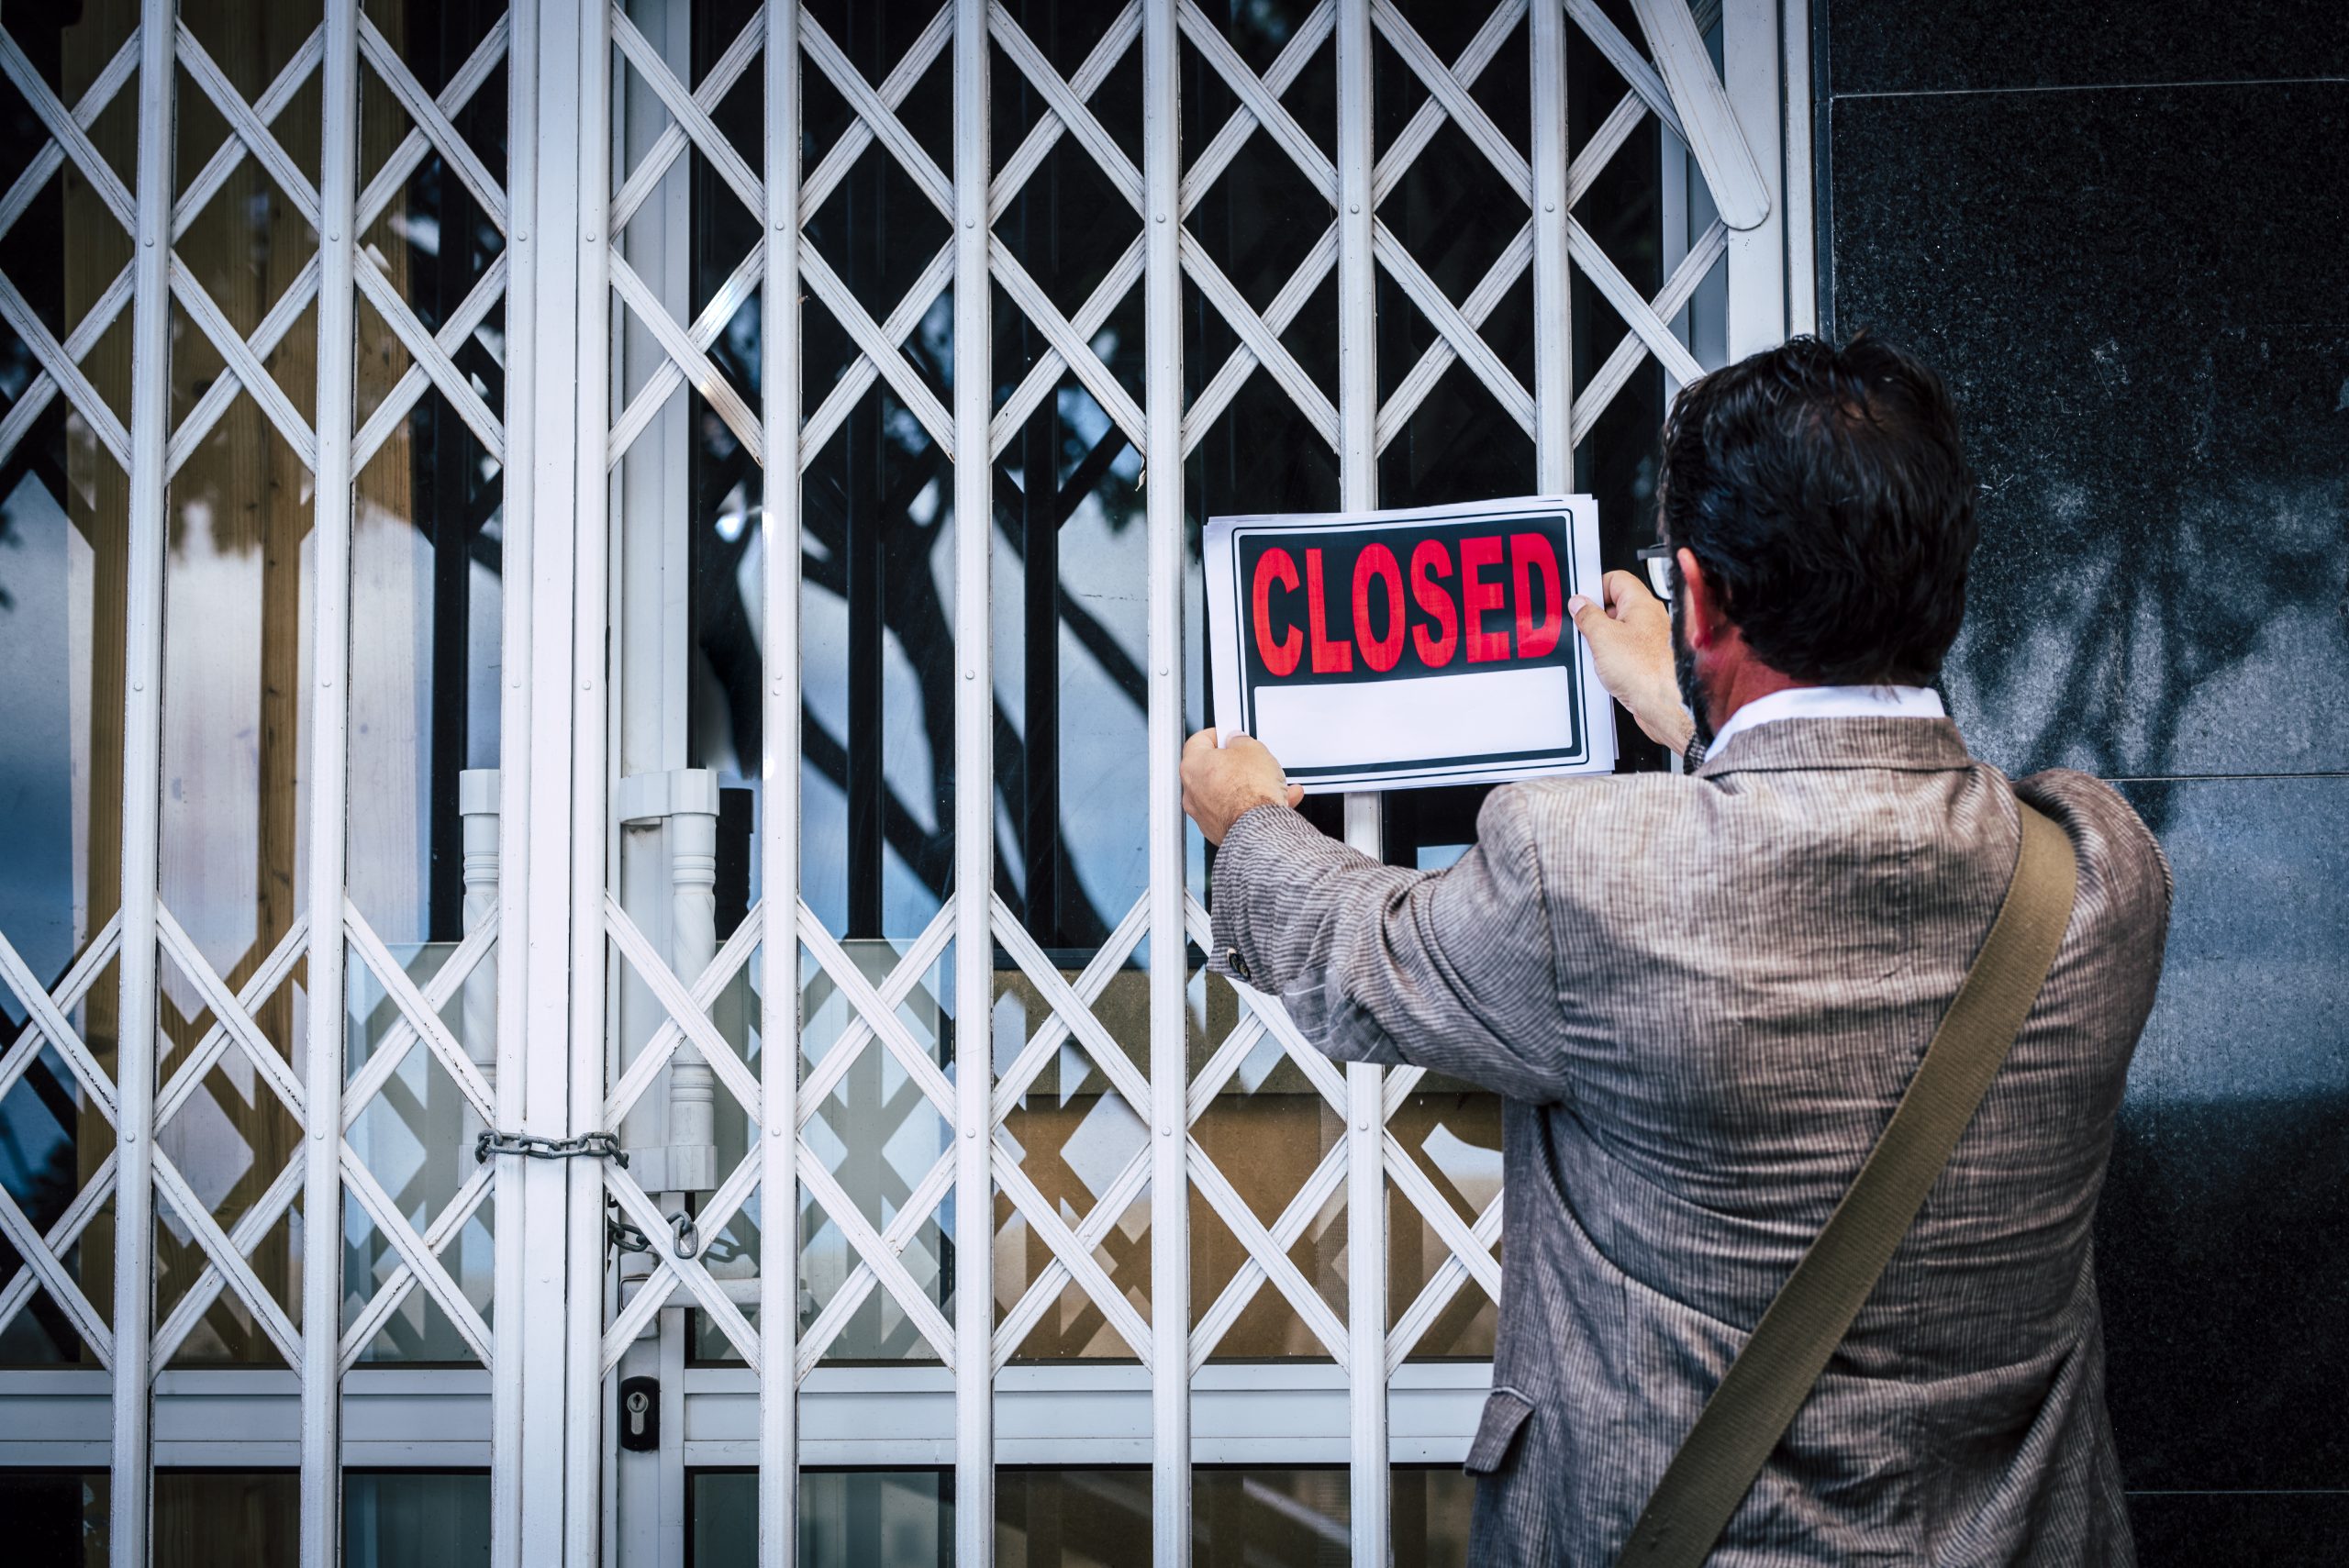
[{"xmin": 1661, "ymin": 333, "xmax": 1976, "ymax": 685}]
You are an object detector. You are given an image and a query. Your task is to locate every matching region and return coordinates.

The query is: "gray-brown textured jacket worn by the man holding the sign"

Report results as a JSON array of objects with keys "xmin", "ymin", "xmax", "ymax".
[{"xmin": 1215, "ymin": 718, "xmax": 2168, "ymax": 1568}]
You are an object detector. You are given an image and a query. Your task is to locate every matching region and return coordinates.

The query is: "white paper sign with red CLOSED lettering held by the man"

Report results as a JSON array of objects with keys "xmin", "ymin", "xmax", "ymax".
[{"xmin": 1205, "ymin": 495, "xmax": 1616, "ymax": 794}]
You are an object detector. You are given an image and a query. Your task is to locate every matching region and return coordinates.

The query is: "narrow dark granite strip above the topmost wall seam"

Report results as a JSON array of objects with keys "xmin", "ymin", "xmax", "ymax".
[{"xmin": 1813, "ymin": 0, "xmax": 2349, "ymax": 96}]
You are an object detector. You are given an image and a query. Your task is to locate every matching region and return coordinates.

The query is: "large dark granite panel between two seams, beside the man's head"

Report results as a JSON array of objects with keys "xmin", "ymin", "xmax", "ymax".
[{"xmin": 1828, "ymin": 79, "xmax": 2349, "ymax": 777}]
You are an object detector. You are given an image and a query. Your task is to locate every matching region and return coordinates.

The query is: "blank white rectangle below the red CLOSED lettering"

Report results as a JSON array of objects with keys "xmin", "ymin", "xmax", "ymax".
[{"xmin": 1257, "ymin": 664, "xmax": 1574, "ymax": 768}]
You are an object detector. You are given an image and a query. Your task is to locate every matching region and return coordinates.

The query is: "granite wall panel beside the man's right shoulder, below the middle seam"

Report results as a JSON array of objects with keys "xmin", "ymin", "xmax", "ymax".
[{"xmin": 2098, "ymin": 777, "xmax": 2349, "ymax": 1493}]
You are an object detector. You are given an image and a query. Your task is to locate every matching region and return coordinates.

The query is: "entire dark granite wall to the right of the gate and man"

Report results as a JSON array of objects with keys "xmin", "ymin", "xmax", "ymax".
[{"xmin": 1813, "ymin": 0, "xmax": 2349, "ymax": 1568}]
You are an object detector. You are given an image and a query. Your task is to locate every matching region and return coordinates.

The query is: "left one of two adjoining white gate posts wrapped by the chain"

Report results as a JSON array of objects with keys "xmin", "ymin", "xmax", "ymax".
[{"xmin": 484, "ymin": 0, "xmax": 540, "ymax": 1568}]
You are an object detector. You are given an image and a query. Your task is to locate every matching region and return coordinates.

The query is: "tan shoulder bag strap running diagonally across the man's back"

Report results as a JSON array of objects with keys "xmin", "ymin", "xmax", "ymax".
[{"xmin": 1620, "ymin": 800, "xmax": 2079, "ymax": 1568}]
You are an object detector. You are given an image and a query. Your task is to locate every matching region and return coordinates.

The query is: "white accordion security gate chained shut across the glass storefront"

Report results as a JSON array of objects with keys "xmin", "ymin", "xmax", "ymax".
[{"xmin": 0, "ymin": 0, "xmax": 1811, "ymax": 1565}]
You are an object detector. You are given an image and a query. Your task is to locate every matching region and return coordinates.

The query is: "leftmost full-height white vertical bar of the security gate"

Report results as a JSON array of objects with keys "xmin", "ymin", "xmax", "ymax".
[{"xmin": 108, "ymin": 0, "xmax": 173, "ymax": 1568}]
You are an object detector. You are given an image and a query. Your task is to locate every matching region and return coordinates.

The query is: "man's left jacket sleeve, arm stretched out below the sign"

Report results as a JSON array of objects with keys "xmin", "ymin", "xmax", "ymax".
[{"xmin": 1212, "ymin": 789, "xmax": 1567, "ymax": 1103}]
